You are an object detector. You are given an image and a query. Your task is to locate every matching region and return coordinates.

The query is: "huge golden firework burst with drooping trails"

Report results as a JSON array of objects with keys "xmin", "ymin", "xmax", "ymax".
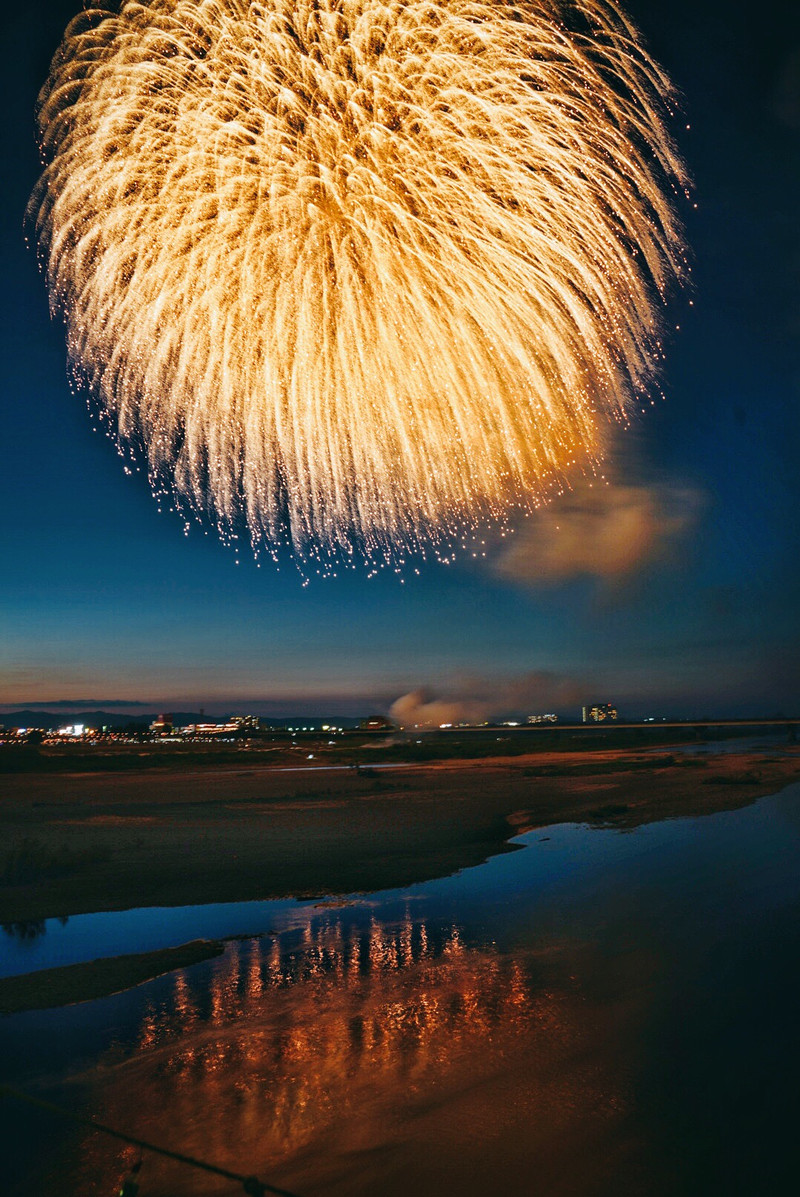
[{"xmin": 30, "ymin": 0, "xmax": 685, "ymax": 557}]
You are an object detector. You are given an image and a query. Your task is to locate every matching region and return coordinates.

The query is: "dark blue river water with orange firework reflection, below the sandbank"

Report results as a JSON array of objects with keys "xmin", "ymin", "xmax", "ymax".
[{"xmin": 0, "ymin": 785, "xmax": 800, "ymax": 1197}]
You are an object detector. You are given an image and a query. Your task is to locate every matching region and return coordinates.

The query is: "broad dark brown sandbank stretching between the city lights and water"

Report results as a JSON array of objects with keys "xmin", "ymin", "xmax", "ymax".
[{"xmin": 0, "ymin": 747, "xmax": 800, "ymax": 923}]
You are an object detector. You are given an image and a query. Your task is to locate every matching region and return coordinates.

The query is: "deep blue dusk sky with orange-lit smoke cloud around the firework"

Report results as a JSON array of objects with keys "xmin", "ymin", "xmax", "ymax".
[{"xmin": 0, "ymin": 0, "xmax": 800, "ymax": 717}]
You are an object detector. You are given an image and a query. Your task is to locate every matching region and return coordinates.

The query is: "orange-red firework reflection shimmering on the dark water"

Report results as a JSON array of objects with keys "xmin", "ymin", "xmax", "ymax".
[{"xmin": 65, "ymin": 911, "xmax": 619, "ymax": 1197}]
